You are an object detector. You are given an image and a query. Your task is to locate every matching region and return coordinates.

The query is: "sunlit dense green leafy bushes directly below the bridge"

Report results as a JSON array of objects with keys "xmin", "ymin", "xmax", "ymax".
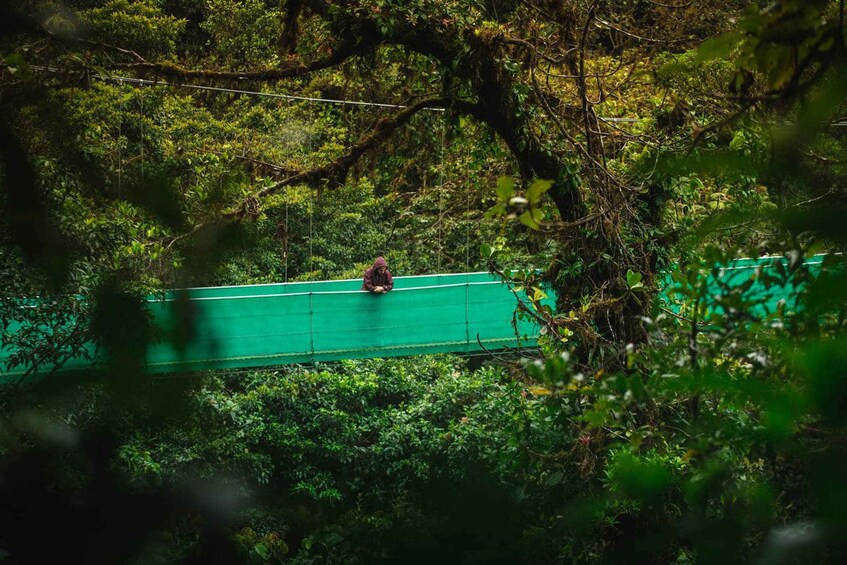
[{"xmin": 127, "ymin": 359, "xmax": 516, "ymax": 501}]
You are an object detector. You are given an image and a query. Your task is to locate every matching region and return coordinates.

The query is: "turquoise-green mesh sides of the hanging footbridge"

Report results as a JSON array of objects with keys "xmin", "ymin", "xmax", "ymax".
[{"xmin": 0, "ymin": 256, "xmax": 836, "ymax": 378}]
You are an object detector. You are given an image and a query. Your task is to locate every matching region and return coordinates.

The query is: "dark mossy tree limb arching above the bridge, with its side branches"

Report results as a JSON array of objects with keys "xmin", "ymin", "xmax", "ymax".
[{"xmin": 102, "ymin": 8, "xmax": 587, "ymax": 221}]
